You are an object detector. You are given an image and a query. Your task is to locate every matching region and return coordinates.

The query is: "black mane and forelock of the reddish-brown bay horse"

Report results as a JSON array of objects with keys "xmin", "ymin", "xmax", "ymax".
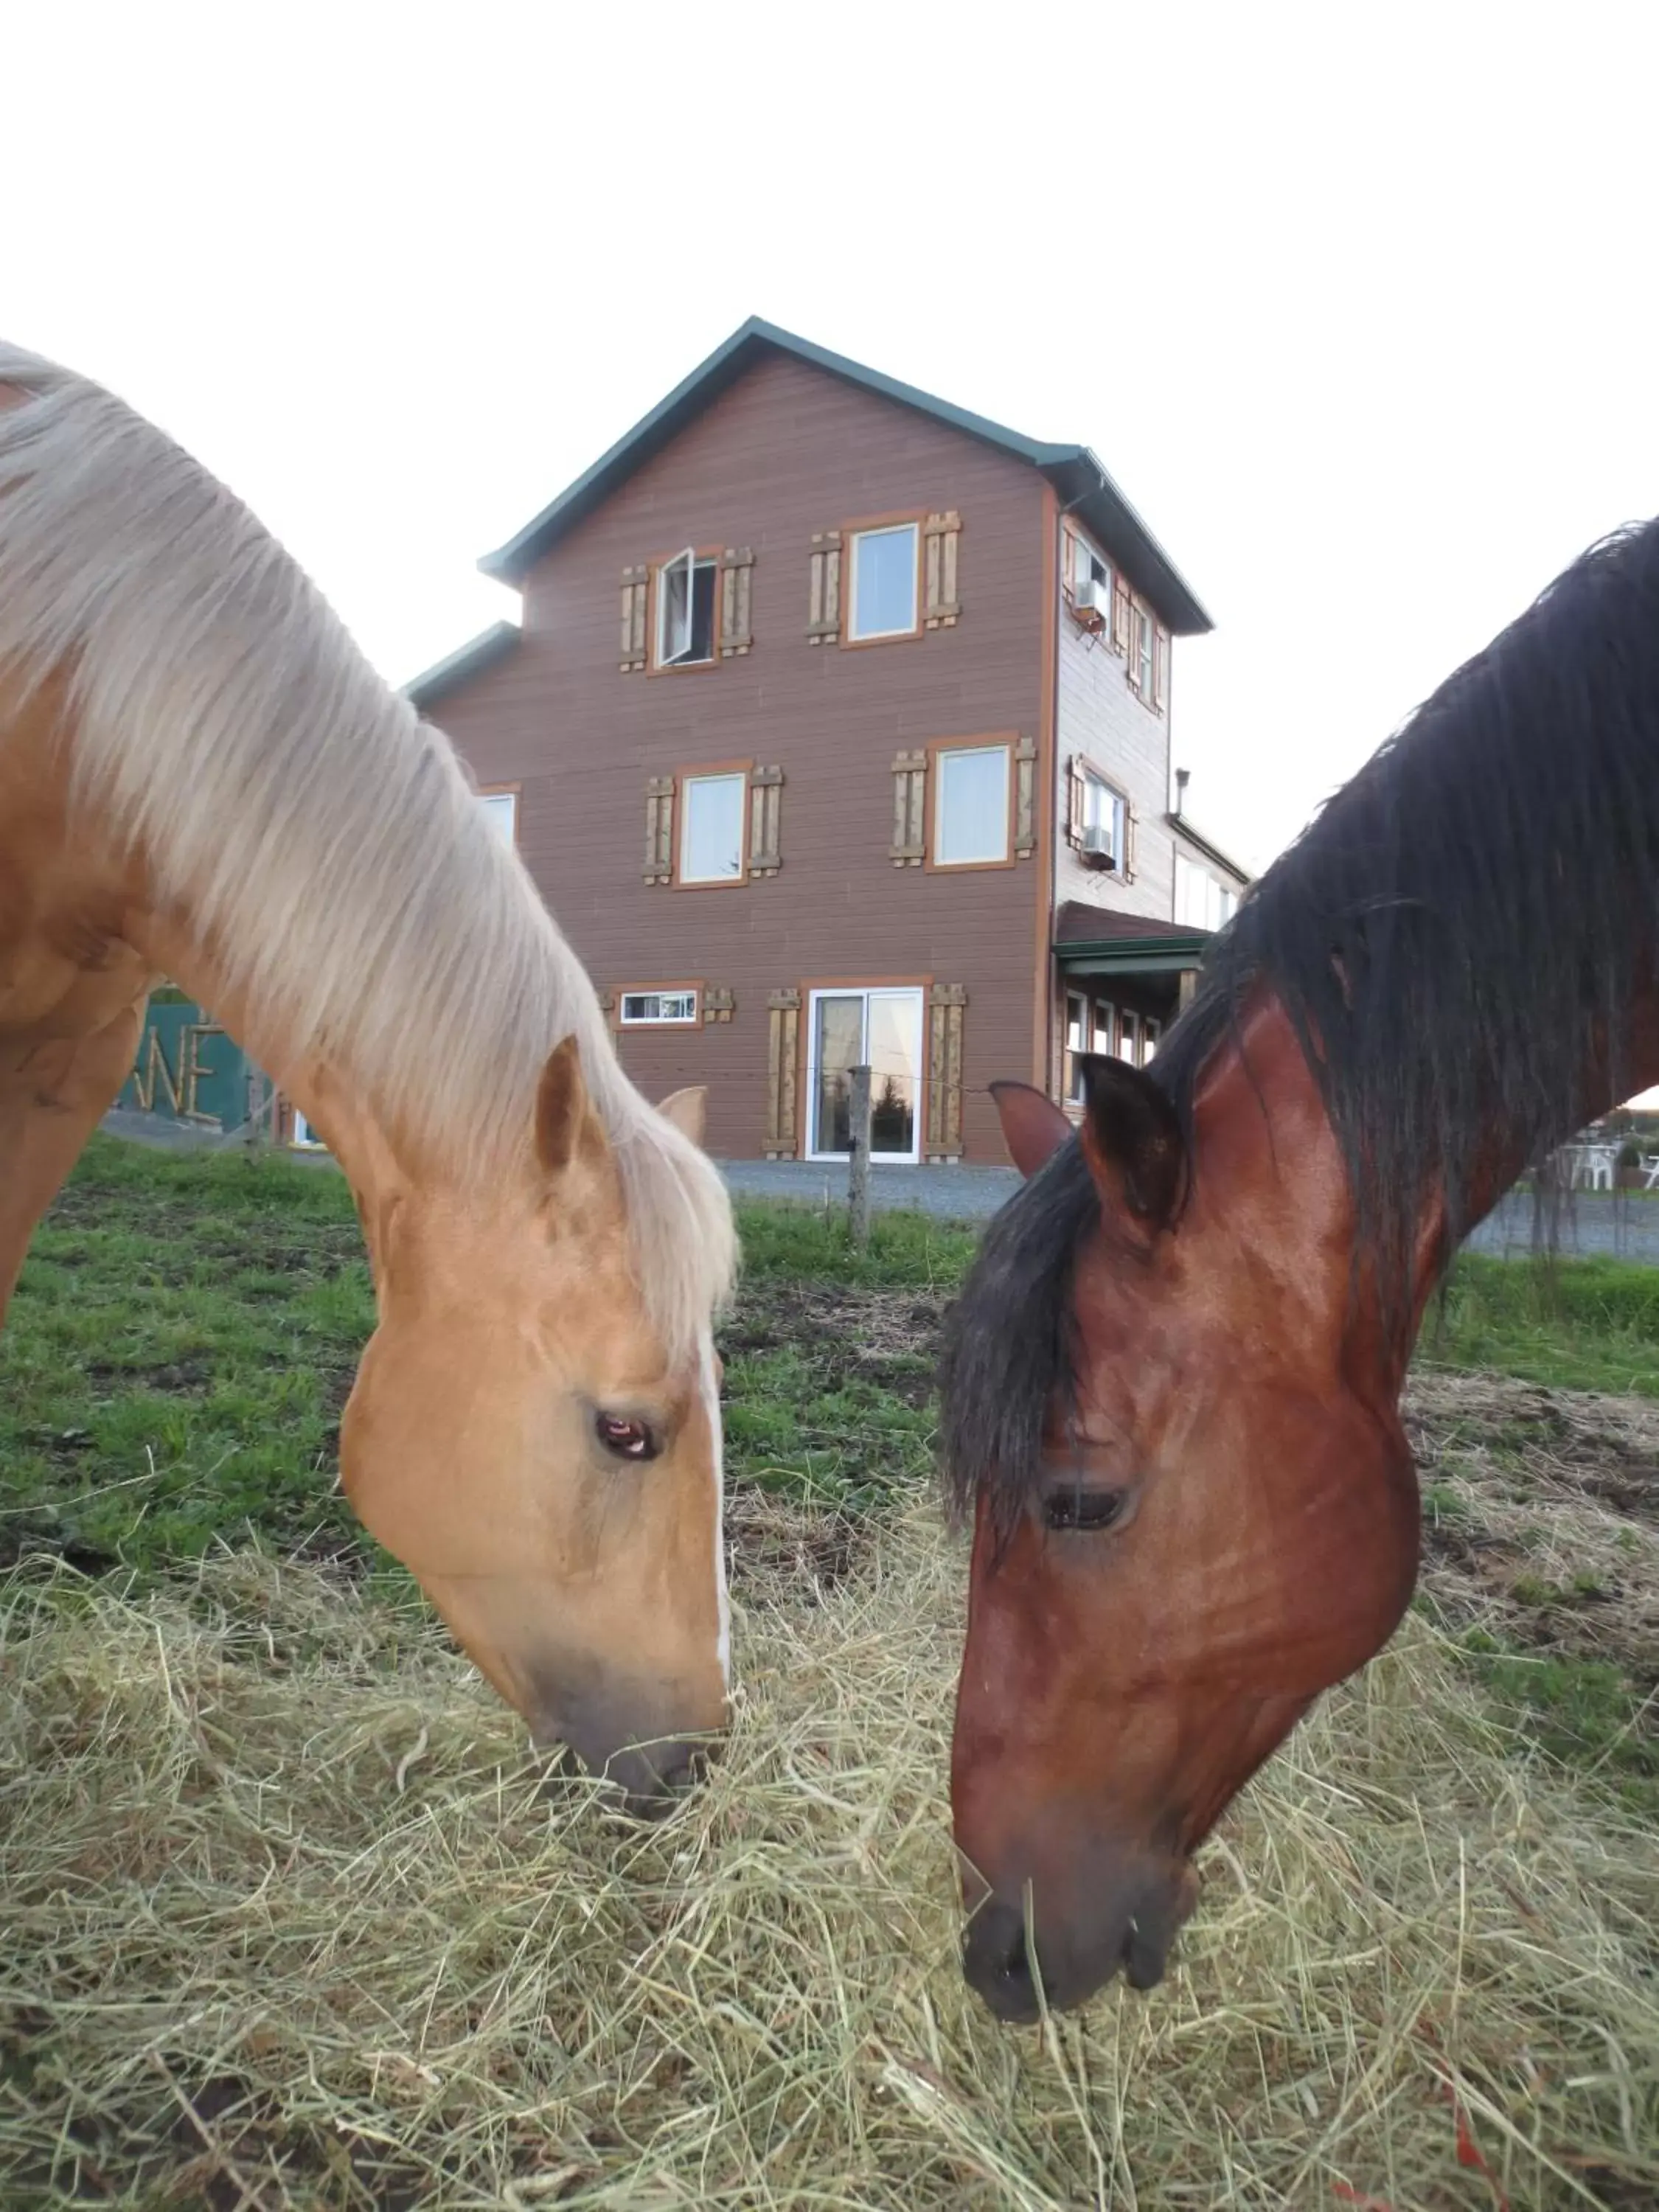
[{"xmin": 942, "ymin": 522, "xmax": 1659, "ymax": 1517}]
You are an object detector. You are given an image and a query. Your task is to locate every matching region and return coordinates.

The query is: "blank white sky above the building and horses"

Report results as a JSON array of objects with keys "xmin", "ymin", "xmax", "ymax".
[{"xmin": 0, "ymin": 0, "xmax": 1659, "ymax": 889}]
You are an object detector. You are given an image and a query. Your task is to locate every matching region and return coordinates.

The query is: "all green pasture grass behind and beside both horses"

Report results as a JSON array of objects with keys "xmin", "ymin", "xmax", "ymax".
[{"xmin": 0, "ymin": 1137, "xmax": 1659, "ymax": 1809}]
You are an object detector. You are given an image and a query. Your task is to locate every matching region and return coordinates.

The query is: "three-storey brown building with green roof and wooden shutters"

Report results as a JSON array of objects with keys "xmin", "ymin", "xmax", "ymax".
[{"xmin": 409, "ymin": 321, "xmax": 1245, "ymax": 1161}]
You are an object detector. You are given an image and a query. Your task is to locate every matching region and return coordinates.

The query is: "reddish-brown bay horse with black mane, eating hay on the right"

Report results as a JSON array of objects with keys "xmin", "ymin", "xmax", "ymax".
[{"xmin": 942, "ymin": 524, "xmax": 1659, "ymax": 2020}]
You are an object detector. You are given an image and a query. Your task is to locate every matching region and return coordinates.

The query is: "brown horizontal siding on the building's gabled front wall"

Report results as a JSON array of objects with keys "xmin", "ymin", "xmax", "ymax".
[{"xmin": 422, "ymin": 358, "xmax": 1044, "ymax": 1161}]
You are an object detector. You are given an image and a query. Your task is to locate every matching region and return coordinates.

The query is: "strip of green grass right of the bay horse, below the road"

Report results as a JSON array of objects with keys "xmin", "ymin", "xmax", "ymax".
[{"xmin": 1418, "ymin": 1252, "xmax": 1659, "ymax": 1398}]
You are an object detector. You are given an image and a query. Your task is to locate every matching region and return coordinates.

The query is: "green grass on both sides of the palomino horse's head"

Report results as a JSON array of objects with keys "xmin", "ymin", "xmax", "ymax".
[{"xmin": 0, "ymin": 1137, "xmax": 973, "ymax": 1573}]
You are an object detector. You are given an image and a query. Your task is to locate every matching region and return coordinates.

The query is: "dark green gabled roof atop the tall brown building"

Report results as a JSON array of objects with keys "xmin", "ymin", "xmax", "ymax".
[{"xmin": 478, "ymin": 314, "xmax": 1214, "ymax": 637}]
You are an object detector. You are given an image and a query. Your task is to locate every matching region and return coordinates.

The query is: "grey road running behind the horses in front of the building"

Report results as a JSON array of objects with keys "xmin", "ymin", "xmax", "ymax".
[{"xmin": 94, "ymin": 1108, "xmax": 1659, "ymax": 1267}]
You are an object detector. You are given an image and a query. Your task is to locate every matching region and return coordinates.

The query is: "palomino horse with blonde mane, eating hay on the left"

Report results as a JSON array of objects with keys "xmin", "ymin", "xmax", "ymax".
[{"xmin": 0, "ymin": 347, "xmax": 734, "ymax": 1807}]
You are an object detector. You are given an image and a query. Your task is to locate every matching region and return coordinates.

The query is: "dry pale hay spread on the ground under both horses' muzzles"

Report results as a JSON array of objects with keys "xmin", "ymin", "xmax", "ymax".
[{"xmin": 0, "ymin": 1442, "xmax": 1659, "ymax": 2212}]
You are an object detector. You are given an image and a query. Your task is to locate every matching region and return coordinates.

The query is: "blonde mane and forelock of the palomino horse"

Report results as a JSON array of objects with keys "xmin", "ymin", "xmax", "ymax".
[{"xmin": 0, "ymin": 345, "xmax": 734, "ymax": 1354}]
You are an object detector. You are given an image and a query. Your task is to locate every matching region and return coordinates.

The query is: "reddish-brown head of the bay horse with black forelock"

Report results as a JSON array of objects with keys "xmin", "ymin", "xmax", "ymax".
[{"xmin": 945, "ymin": 1020, "xmax": 1418, "ymax": 2020}]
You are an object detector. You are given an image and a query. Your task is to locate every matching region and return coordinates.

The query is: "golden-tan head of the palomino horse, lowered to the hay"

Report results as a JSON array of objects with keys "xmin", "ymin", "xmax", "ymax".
[{"xmin": 316, "ymin": 1037, "xmax": 728, "ymax": 1812}]
